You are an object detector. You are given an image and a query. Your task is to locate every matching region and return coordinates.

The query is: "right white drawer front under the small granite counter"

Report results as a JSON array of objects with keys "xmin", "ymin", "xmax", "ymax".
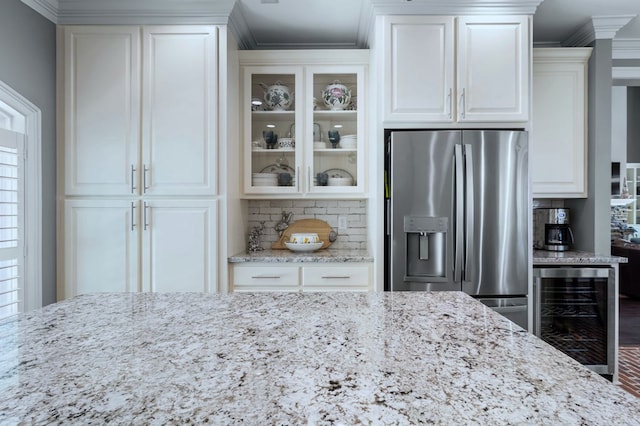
[{"xmin": 302, "ymin": 264, "xmax": 371, "ymax": 291}]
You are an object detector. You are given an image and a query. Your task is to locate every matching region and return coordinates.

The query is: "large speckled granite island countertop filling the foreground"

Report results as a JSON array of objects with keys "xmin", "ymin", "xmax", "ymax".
[{"xmin": 0, "ymin": 292, "xmax": 640, "ymax": 425}]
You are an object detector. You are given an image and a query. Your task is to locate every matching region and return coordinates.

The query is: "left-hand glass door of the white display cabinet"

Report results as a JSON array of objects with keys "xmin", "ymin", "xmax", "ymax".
[{"xmin": 243, "ymin": 67, "xmax": 304, "ymax": 194}]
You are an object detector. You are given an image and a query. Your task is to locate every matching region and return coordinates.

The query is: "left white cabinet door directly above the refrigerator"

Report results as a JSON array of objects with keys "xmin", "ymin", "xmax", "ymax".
[{"xmin": 384, "ymin": 16, "xmax": 454, "ymax": 121}]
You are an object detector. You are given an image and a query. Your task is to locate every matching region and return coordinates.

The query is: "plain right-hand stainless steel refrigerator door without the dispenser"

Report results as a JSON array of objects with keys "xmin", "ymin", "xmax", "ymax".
[{"xmin": 462, "ymin": 130, "xmax": 529, "ymax": 296}]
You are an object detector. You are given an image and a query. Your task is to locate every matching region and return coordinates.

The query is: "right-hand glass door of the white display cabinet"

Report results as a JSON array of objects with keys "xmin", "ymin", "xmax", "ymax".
[{"xmin": 305, "ymin": 66, "xmax": 364, "ymax": 193}]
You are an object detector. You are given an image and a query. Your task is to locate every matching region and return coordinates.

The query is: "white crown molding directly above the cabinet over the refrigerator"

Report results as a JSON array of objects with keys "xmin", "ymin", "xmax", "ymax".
[{"xmin": 370, "ymin": 0, "xmax": 542, "ymax": 15}]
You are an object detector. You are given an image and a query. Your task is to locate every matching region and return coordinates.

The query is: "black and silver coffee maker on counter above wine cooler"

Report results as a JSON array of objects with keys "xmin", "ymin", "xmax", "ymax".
[{"xmin": 533, "ymin": 208, "xmax": 574, "ymax": 251}]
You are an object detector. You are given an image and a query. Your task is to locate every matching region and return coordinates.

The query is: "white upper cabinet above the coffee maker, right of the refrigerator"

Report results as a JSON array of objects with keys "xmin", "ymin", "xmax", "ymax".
[{"xmin": 530, "ymin": 48, "xmax": 591, "ymax": 198}]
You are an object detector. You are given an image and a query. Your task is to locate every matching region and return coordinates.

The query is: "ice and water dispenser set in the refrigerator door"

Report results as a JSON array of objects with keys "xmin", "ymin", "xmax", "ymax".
[{"xmin": 404, "ymin": 216, "xmax": 449, "ymax": 282}]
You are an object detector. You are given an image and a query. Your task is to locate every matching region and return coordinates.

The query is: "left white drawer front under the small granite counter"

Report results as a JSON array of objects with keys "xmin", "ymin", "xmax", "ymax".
[{"xmin": 233, "ymin": 265, "xmax": 300, "ymax": 291}]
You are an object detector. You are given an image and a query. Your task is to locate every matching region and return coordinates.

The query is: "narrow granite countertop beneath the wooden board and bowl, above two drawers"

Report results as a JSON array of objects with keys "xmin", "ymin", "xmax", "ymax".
[{"xmin": 228, "ymin": 248, "xmax": 373, "ymax": 263}]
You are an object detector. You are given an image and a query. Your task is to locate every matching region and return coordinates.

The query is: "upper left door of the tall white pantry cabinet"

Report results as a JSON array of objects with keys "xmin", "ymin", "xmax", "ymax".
[{"xmin": 64, "ymin": 27, "xmax": 140, "ymax": 195}]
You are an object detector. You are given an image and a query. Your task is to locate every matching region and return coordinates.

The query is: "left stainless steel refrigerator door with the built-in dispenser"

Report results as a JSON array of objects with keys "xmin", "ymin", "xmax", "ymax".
[{"xmin": 387, "ymin": 131, "xmax": 463, "ymax": 291}]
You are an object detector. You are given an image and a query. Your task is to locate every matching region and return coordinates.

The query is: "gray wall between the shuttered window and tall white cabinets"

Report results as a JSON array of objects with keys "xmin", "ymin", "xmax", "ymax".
[{"xmin": 0, "ymin": 0, "xmax": 56, "ymax": 305}]
